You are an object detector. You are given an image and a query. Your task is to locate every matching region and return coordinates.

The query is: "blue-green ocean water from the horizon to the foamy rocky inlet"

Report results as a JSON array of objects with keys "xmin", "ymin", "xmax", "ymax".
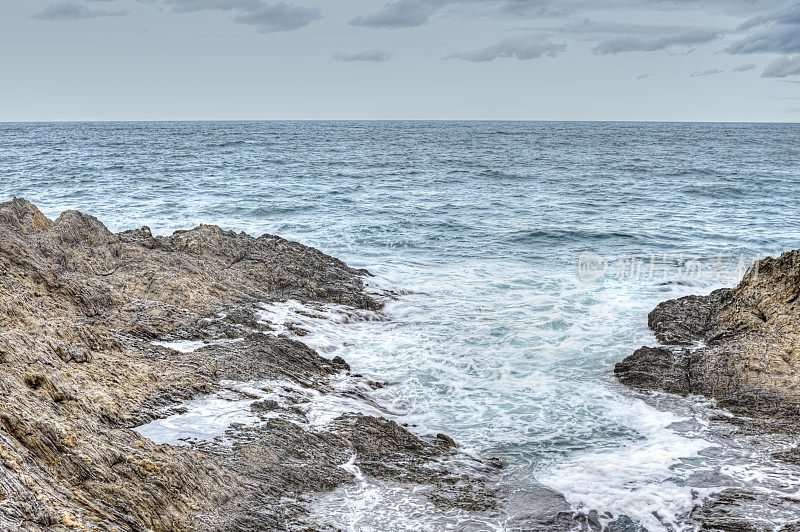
[{"xmin": 0, "ymin": 122, "xmax": 800, "ymax": 530}]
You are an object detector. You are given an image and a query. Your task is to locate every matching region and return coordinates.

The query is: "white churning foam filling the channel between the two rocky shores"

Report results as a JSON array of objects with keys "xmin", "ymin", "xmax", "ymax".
[{"xmin": 252, "ymin": 270, "xmax": 736, "ymax": 530}]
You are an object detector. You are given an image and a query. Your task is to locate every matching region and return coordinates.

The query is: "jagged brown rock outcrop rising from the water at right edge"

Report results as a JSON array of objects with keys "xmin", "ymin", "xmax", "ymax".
[{"xmin": 615, "ymin": 250, "xmax": 800, "ymax": 417}]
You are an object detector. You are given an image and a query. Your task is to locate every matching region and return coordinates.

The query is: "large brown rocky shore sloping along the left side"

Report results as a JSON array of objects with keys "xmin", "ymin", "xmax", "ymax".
[{"xmin": 0, "ymin": 199, "xmax": 500, "ymax": 531}]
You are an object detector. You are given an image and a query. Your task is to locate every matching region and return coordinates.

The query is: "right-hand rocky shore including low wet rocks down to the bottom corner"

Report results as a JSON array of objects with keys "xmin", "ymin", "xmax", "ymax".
[{"xmin": 615, "ymin": 250, "xmax": 800, "ymax": 531}]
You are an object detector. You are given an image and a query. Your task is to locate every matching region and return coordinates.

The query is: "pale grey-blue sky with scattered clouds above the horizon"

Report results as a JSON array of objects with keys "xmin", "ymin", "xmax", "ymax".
[{"xmin": 0, "ymin": 0, "xmax": 800, "ymax": 122}]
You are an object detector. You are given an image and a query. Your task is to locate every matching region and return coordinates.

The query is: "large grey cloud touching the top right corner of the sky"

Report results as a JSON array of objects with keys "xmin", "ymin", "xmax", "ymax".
[{"xmin": 725, "ymin": 2, "xmax": 800, "ymax": 54}]
